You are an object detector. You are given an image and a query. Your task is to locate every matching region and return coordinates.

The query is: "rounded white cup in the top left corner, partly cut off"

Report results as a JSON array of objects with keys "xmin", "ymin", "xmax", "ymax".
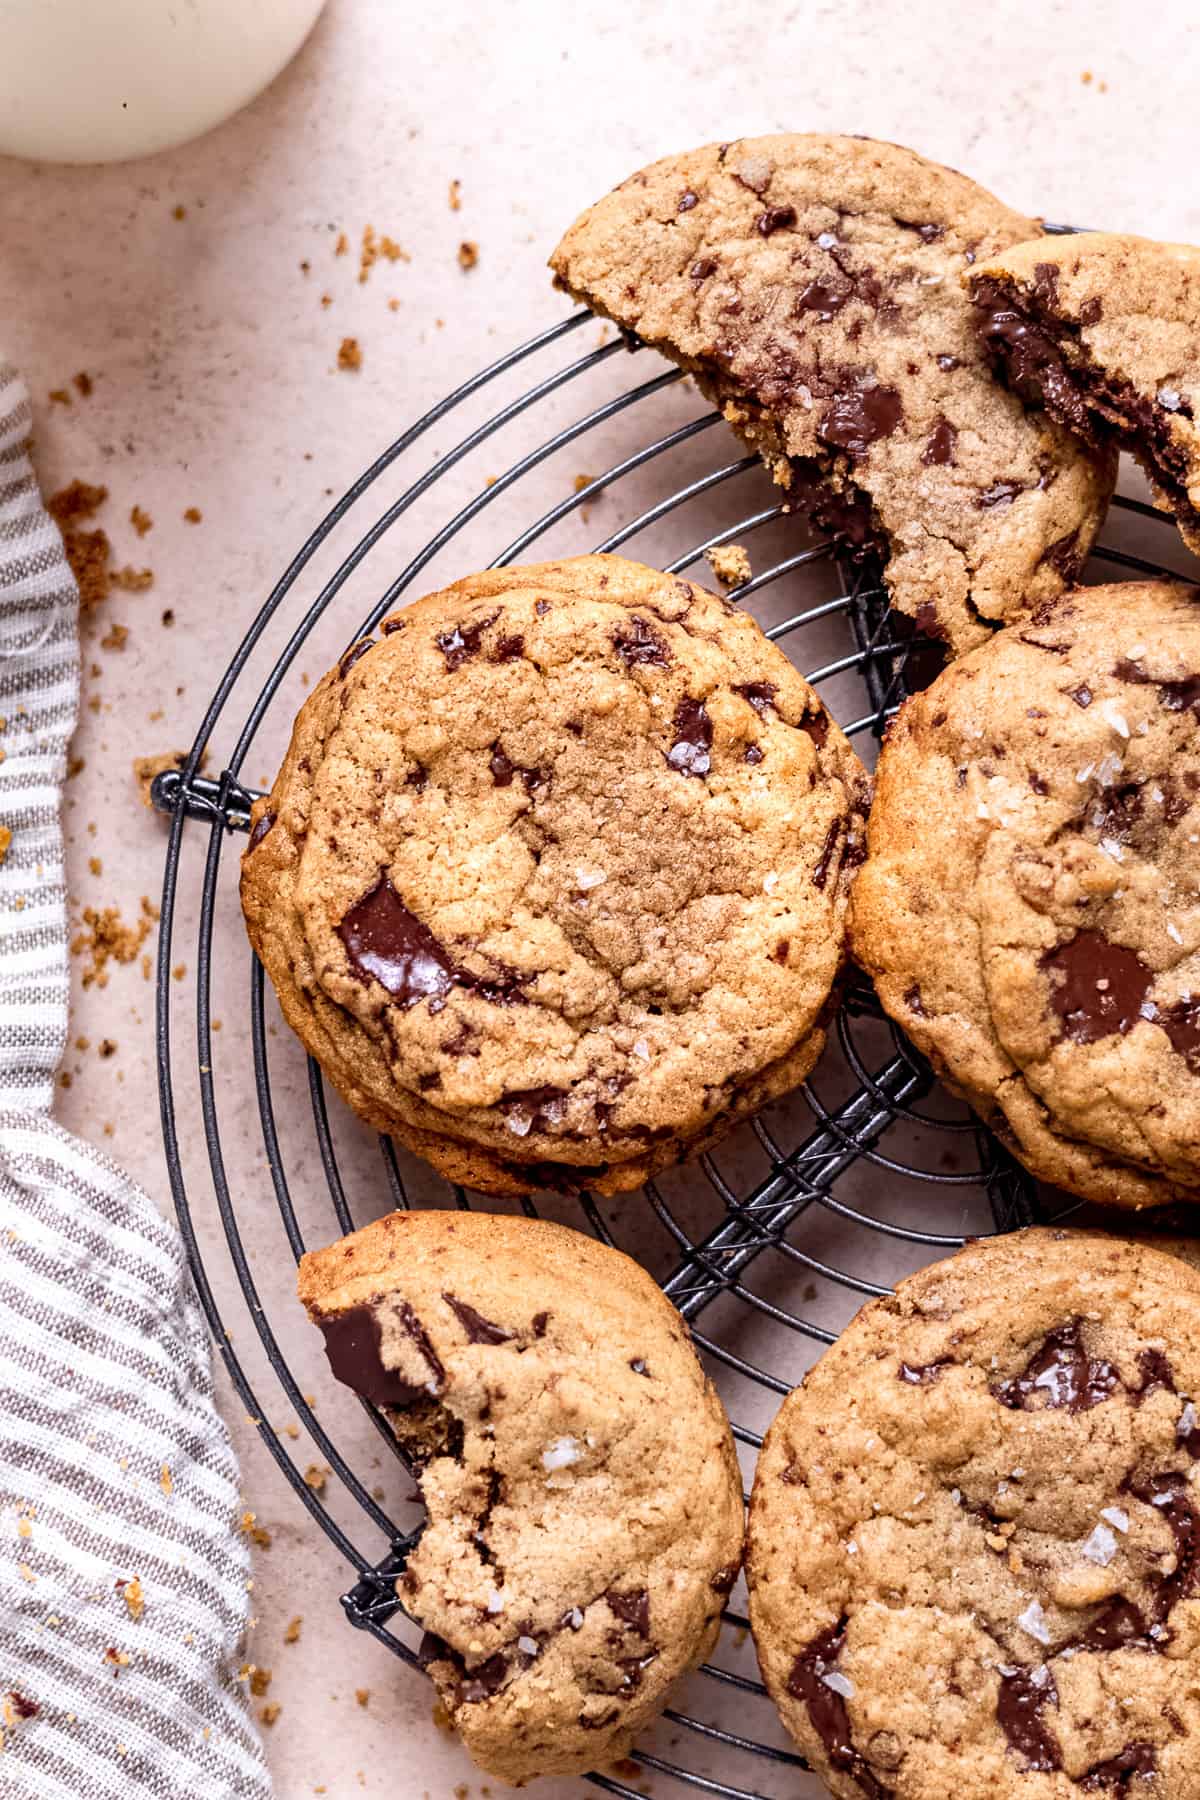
[{"xmin": 0, "ymin": 0, "xmax": 324, "ymax": 162}]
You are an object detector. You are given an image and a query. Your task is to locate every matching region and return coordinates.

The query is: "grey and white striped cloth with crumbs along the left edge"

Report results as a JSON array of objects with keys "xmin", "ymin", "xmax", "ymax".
[{"xmin": 0, "ymin": 365, "xmax": 270, "ymax": 1800}]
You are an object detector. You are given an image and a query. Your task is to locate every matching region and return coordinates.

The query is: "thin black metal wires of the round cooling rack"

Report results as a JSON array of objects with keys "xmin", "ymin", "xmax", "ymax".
[{"xmin": 155, "ymin": 311, "xmax": 1187, "ymax": 1800}]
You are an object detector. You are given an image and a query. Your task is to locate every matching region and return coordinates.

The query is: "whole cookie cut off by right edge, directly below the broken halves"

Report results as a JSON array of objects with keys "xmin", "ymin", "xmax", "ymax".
[{"xmin": 851, "ymin": 581, "xmax": 1200, "ymax": 1206}]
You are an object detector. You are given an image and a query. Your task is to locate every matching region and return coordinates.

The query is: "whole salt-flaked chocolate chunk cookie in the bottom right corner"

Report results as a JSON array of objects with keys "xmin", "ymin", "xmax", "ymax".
[{"xmin": 747, "ymin": 1231, "xmax": 1200, "ymax": 1800}]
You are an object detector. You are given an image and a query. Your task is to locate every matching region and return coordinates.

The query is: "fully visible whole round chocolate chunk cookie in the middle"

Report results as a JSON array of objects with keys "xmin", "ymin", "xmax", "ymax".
[{"xmin": 241, "ymin": 556, "xmax": 867, "ymax": 1193}]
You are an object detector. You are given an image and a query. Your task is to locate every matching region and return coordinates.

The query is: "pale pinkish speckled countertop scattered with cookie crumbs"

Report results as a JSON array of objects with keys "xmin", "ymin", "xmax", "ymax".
[{"xmin": 0, "ymin": 0, "xmax": 1200, "ymax": 1800}]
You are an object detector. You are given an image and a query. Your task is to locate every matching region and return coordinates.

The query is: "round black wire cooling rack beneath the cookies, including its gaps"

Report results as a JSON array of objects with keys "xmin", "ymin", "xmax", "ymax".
[{"xmin": 155, "ymin": 295, "xmax": 1187, "ymax": 1800}]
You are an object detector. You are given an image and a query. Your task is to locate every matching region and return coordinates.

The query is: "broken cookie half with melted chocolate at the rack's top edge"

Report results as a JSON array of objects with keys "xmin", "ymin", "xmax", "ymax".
[{"xmin": 551, "ymin": 135, "xmax": 1115, "ymax": 652}]
